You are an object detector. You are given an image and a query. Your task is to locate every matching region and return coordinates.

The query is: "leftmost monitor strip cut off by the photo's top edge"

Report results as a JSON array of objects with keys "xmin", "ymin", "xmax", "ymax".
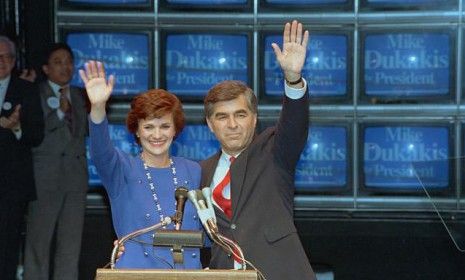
[{"xmin": 59, "ymin": 0, "xmax": 153, "ymax": 11}]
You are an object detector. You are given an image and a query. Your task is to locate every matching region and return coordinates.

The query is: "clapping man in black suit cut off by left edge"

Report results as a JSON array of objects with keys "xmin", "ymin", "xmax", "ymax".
[{"xmin": 0, "ymin": 36, "xmax": 44, "ymax": 280}]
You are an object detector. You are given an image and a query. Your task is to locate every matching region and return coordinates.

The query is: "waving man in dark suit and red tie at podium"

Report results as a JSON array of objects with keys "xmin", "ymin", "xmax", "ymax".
[{"xmin": 201, "ymin": 21, "xmax": 315, "ymax": 280}]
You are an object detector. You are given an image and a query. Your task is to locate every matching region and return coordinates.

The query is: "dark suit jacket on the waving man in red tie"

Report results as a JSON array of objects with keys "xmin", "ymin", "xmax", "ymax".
[{"xmin": 201, "ymin": 94, "xmax": 315, "ymax": 280}]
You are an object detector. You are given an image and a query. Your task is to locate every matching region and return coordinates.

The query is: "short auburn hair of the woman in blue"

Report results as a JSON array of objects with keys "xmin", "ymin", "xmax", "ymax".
[{"xmin": 126, "ymin": 89, "xmax": 185, "ymax": 144}]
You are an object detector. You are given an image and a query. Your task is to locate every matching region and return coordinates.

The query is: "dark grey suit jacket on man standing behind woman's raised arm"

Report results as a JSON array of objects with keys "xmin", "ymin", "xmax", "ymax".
[{"xmin": 33, "ymin": 81, "xmax": 88, "ymax": 192}]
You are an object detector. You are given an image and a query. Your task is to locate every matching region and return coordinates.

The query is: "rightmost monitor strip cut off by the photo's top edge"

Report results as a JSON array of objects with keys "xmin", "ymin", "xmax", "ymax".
[{"xmin": 360, "ymin": 0, "xmax": 458, "ymax": 10}]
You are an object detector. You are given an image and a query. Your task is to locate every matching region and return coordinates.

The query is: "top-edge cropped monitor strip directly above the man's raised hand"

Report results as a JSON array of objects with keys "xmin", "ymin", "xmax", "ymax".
[{"xmin": 260, "ymin": 0, "xmax": 354, "ymax": 10}]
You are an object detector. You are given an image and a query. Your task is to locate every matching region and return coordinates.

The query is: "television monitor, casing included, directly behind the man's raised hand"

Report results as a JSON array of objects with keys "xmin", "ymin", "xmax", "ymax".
[{"xmin": 260, "ymin": 31, "xmax": 352, "ymax": 102}]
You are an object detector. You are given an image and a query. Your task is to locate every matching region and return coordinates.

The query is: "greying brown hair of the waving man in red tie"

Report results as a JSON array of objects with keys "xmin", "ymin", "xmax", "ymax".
[{"xmin": 203, "ymin": 80, "xmax": 257, "ymax": 118}]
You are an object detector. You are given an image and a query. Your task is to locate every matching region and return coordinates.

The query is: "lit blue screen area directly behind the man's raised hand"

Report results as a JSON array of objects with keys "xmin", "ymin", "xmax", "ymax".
[{"xmin": 263, "ymin": 34, "xmax": 348, "ymax": 97}]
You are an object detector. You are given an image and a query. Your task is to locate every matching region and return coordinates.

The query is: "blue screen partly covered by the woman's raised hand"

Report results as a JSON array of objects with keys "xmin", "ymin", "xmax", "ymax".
[{"xmin": 66, "ymin": 32, "xmax": 150, "ymax": 95}]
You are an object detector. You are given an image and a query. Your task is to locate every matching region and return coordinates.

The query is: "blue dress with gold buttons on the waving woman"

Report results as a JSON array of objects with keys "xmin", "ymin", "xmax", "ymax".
[{"xmin": 89, "ymin": 119, "xmax": 201, "ymax": 269}]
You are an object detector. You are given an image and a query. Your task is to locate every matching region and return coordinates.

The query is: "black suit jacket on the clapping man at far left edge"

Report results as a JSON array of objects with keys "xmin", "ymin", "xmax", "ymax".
[{"xmin": 0, "ymin": 76, "xmax": 44, "ymax": 201}]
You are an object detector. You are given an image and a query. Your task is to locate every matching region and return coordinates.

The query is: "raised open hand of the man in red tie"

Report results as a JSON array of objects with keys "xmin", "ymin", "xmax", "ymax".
[{"xmin": 271, "ymin": 20, "xmax": 309, "ymax": 82}]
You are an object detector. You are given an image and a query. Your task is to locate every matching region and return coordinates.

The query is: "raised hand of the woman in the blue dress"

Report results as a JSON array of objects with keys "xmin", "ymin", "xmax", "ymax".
[{"xmin": 79, "ymin": 60, "xmax": 115, "ymax": 106}]
